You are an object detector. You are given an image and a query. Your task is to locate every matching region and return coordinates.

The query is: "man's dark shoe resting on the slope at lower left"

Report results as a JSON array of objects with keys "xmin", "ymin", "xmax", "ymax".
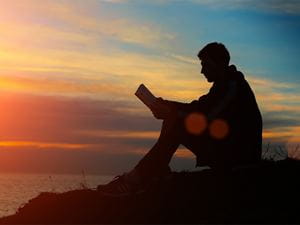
[{"xmin": 97, "ymin": 173, "xmax": 146, "ymax": 197}]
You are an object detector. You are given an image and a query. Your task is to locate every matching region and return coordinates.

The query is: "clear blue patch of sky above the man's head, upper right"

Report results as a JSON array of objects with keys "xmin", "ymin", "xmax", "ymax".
[{"xmin": 104, "ymin": 1, "xmax": 300, "ymax": 82}]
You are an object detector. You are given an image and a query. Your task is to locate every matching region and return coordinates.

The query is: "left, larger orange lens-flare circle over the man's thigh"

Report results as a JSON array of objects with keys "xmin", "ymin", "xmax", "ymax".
[{"xmin": 184, "ymin": 112, "xmax": 207, "ymax": 135}]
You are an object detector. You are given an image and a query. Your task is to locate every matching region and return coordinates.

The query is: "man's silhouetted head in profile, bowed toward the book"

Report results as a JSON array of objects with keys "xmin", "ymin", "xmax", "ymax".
[{"xmin": 198, "ymin": 42, "xmax": 230, "ymax": 82}]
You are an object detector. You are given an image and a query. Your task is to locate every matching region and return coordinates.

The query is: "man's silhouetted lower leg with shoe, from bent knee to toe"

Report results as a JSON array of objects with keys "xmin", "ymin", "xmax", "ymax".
[{"xmin": 98, "ymin": 116, "xmax": 183, "ymax": 196}]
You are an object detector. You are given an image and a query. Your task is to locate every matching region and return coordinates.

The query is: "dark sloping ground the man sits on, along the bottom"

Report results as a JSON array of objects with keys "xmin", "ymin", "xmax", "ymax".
[{"xmin": 0, "ymin": 160, "xmax": 300, "ymax": 224}]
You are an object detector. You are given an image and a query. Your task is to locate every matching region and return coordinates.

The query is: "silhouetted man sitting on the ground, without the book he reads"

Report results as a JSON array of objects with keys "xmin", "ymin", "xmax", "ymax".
[{"xmin": 99, "ymin": 42, "xmax": 262, "ymax": 196}]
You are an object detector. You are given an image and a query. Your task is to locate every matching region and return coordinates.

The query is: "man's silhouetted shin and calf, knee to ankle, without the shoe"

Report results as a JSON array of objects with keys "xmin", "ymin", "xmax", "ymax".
[{"xmin": 134, "ymin": 113, "xmax": 184, "ymax": 180}]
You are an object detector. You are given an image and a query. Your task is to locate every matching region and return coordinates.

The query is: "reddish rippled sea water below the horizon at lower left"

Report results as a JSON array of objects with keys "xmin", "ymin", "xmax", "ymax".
[{"xmin": 0, "ymin": 173, "xmax": 112, "ymax": 217}]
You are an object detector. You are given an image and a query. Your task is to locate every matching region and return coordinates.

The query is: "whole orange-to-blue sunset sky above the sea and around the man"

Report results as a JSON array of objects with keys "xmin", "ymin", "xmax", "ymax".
[{"xmin": 0, "ymin": 0, "xmax": 300, "ymax": 173}]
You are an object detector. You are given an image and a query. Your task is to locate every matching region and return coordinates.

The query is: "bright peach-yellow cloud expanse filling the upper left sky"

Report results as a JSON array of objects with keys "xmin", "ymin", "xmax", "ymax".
[{"xmin": 0, "ymin": 0, "xmax": 207, "ymax": 101}]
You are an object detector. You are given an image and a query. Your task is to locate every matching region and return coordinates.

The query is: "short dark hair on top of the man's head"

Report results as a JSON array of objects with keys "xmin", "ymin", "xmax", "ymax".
[{"xmin": 198, "ymin": 42, "xmax": 230, "ymax": 66}]
